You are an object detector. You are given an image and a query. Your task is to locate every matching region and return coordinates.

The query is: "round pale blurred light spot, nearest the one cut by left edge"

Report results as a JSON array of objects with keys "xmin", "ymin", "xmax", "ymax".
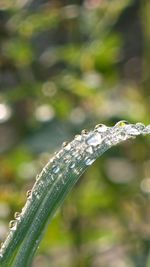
[{"xmin": 35, "ymin": 105, "xmax": 55, "ymax": 122}]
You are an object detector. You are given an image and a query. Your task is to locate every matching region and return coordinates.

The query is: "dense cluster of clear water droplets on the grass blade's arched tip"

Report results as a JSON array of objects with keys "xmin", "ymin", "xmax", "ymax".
[{"xmin": 44, "ymin": 121, "xmax": 150, "ymax": 174}]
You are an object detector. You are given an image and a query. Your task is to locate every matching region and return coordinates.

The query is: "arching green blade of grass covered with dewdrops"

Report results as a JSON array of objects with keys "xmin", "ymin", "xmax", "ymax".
[{"xmin": 0, "ymin": 121, "xmax": 150, "ymax": 267}]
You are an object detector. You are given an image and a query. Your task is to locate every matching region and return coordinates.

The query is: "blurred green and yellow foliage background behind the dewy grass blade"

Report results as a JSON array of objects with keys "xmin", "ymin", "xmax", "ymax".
[{"xmin": 0, "ymin": 0, "xmax": 150, "ymax": 267}]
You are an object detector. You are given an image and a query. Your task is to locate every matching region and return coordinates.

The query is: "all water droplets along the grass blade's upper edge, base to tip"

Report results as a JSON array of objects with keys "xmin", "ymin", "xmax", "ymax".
[{"xmin": 0, "ymin": 121, "xmax": 150, "ymax": 257}]
